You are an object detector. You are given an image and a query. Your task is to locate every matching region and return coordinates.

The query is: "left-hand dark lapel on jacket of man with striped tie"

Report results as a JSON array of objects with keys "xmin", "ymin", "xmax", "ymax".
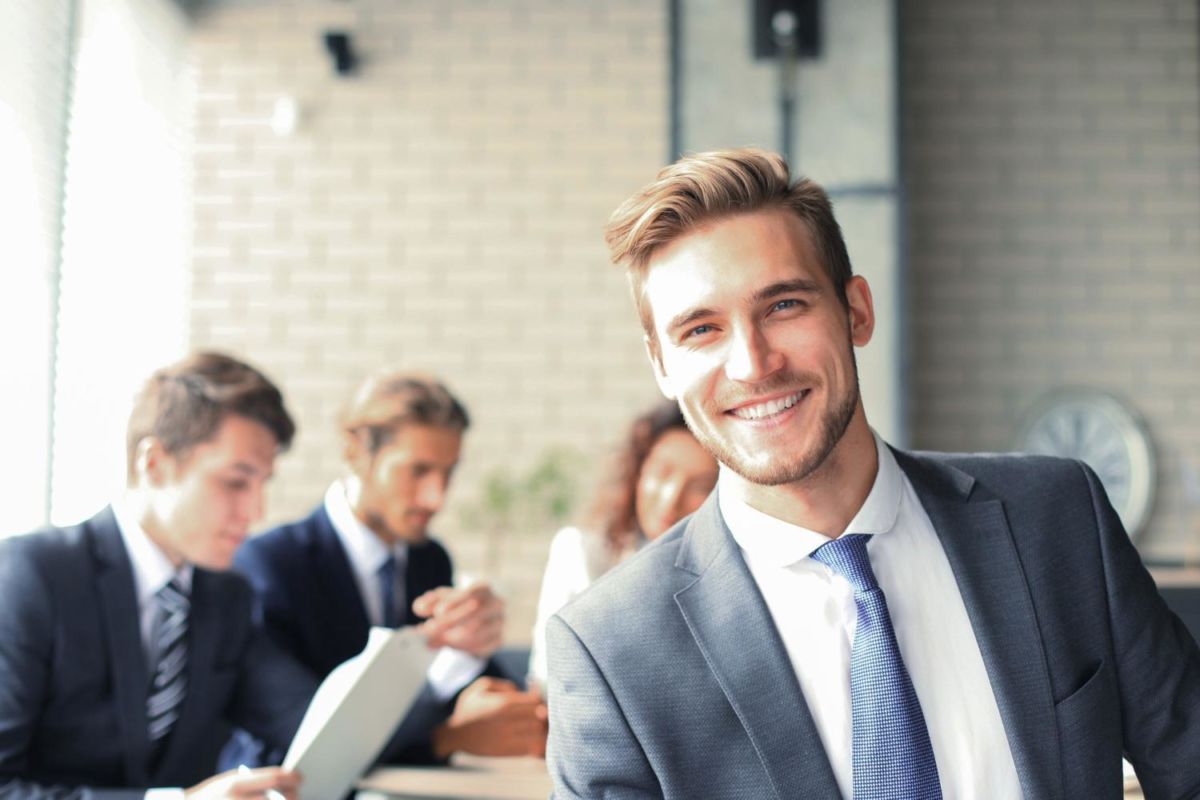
[{"xmin": 88, "ymin": 509, "xmax": 150, "ymax": 786}]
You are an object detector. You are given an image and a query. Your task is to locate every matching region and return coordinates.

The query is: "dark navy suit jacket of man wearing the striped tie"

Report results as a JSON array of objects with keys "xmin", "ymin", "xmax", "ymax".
[{"xmin": 0, "ymin": 509, "xmax": 316, "ymax": 798}]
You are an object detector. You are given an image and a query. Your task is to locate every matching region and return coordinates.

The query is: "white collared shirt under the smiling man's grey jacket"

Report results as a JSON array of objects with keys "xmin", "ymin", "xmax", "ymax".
[{"xmin": 718, "ymin": 437, "xmax": 1021, "ymax": 800}]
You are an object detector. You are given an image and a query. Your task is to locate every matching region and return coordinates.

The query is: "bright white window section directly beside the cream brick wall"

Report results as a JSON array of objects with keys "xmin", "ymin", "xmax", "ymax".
[{"xmin": 50, "ymin": 0, "xmax": 194, "ymax": 524}]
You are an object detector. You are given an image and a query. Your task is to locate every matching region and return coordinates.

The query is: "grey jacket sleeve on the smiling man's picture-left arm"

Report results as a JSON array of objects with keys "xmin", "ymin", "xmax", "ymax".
[{"xmin": 546, "ymin": 615, "xmax": 662, "ymax": 800}]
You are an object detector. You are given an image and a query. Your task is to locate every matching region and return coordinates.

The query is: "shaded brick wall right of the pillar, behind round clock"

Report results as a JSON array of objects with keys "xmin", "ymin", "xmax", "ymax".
[{"xmin": 900, "ymin": 0, "xmax": 1200, "ymax": 559}]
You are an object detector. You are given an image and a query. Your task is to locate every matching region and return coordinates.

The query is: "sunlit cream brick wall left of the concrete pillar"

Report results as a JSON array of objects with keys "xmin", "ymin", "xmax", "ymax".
[{"xmin": 191, "ymin": 0, "xmax": 668, "ymax": 640}]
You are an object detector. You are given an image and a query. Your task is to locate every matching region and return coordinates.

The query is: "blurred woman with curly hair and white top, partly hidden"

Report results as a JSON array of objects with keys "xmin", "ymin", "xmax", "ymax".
[{"xmin": 529, "ymin": 403, "xmax": 716, "ymax": 686}]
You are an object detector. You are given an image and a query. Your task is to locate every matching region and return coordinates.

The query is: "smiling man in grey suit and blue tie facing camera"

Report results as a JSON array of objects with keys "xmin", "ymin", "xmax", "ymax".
[{"xmin": 547, "ymin": 150, "xmax": 1200, "ymax": 800}]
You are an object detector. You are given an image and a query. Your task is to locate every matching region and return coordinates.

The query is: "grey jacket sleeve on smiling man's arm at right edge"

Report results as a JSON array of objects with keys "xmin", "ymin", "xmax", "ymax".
[{"xmin": 1081, "ymin": 465, "xmax": 1200, "ymax": 800}]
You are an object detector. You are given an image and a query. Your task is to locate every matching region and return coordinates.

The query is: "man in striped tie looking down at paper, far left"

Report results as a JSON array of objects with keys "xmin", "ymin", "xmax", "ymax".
[{"xmin": 0, "ymin": 353, "xmax": 316, "ymax": 799}]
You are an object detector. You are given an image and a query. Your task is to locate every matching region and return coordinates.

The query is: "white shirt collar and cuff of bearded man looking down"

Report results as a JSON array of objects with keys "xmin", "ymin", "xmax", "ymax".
[{"xmin": 325, "ymin": 477, "xmax": 486, "ymax": 700}]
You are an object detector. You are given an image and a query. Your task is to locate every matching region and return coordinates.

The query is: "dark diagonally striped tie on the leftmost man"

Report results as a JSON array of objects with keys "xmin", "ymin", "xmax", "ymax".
[{"xmin": 146, "ymin": 579, "xmax": 191, "ymax": 759}]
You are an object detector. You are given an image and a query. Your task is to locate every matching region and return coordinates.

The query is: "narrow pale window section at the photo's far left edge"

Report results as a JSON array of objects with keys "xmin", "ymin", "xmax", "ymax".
[{"xmin": 0, "ymin": 0, "xmax": 74, "ymax": 535}]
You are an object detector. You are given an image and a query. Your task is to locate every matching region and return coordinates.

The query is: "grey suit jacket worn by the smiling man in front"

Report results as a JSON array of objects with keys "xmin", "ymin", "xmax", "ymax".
[{"xmin": 548, "ymin": 452, "xmax": 1200, "ymax": 800}]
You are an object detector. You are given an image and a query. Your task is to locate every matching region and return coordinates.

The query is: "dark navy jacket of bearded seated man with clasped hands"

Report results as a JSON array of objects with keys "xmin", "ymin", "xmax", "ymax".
[{"xmin": 222, "ymin": 505, "xmax": 470, "ymax": 765}]
